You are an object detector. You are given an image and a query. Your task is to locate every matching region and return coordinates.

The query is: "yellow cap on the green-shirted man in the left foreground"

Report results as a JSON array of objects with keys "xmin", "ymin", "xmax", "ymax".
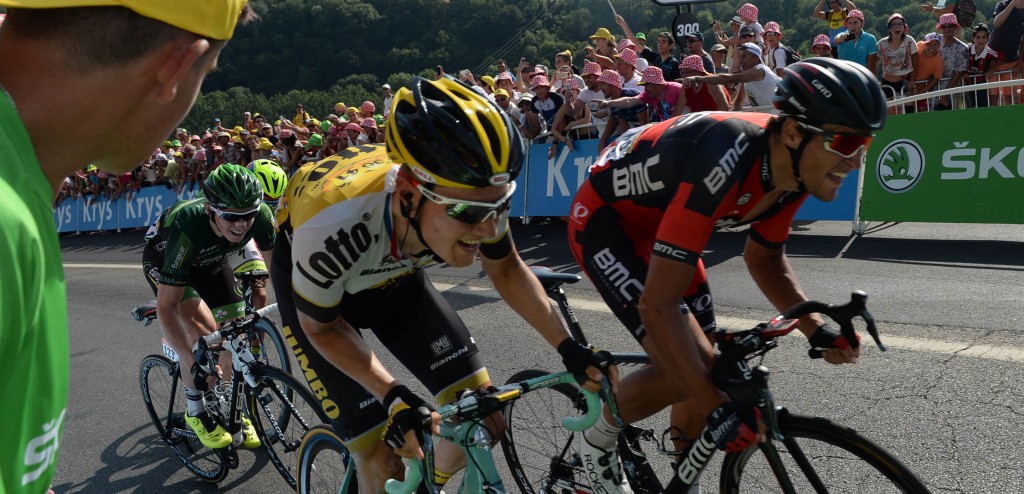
[{"xmin": 0, "ymin": 0, "xmax": 248, "ymax": 40}]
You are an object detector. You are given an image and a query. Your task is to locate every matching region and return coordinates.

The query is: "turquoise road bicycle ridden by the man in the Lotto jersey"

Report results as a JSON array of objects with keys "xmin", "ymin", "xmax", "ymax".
[{"xmin": 298, "ymin": 366, "xmax": 601, "ymax": 494}]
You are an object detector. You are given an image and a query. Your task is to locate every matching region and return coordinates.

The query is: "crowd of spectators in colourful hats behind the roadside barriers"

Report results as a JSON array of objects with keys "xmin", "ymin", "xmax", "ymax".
[{"xmin": 56, "ymin": 0, "xmax": 1024, "ymax": 204}]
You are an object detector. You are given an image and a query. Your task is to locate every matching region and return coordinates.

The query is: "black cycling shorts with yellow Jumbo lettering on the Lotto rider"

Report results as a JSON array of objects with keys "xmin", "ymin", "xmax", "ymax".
[{"xmin": 270, "ymin": 235, "xmax": 489, "ymax": 451}]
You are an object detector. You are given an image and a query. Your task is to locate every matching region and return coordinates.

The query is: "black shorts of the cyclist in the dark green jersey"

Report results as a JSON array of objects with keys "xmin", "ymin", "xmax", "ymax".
[{"xmin": 142, "ymin": 254, "xmax": 246, "ymax": 324}]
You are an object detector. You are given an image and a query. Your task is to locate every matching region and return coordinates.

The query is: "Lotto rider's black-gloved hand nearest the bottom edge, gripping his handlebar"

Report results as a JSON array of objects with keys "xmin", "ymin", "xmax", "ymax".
[{"xmin": 381, "ymin": 384, "xmax": 441, "ymax": 460}]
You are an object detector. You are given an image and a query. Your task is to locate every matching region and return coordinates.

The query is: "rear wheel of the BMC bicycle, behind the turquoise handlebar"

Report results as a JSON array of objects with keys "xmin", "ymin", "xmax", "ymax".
[{"xmin": 502, "ymin": 369, "xmax": 590, "ymax": 494}]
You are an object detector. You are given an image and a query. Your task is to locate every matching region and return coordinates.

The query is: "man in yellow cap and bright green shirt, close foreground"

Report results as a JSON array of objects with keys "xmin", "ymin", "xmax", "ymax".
[{"xmin": 0, "ymin": 0, "xmax": 251, "ymax": 494}]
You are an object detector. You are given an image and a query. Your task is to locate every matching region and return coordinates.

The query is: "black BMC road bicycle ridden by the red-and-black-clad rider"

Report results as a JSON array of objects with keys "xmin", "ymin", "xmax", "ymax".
[{"xmin": 502, "ymin": 269, "xmax": 929, "ymax": 494}]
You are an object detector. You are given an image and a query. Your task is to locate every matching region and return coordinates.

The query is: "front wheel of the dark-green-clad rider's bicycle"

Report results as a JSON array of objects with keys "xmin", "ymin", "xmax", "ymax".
[{"xmin": 248, "ymin": 366, "xmax": 329, "ymax": 489}]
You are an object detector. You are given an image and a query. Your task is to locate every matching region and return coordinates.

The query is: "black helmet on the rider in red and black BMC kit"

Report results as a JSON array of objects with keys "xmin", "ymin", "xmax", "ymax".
[{"xmin": 772, "ymin": 57, "xmax": 887, "ymax": 132}]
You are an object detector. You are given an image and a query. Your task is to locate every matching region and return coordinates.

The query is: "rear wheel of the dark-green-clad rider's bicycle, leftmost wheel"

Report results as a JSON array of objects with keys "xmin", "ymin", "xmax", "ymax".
[{"xmin": 138, "ymin": 355, "xmax": 229, "ymax": 484}]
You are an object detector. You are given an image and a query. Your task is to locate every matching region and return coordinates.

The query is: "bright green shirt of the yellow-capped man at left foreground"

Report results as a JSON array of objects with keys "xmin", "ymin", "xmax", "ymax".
[{"xmin": 0, "ymin": 90, "xmax": 70, "ymax": 494}]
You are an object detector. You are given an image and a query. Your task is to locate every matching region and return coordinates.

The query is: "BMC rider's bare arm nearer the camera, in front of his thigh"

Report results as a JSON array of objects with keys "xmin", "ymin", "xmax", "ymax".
[{"xmin": 637, "ymin": 255, "xmax": 726, "ymax": 416}]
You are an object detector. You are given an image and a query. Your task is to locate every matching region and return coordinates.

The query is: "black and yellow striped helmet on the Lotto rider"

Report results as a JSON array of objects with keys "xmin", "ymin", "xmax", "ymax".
[{"xmin": 385, "ymin": 77, "xmax": 526, "ymax": 189}]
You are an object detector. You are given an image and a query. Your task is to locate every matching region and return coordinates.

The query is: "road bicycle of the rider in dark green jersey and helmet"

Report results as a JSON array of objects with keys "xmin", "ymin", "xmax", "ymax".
[{"xmin": 132, "ymin": 305, "xmax": 328, "ymax": 488}]
